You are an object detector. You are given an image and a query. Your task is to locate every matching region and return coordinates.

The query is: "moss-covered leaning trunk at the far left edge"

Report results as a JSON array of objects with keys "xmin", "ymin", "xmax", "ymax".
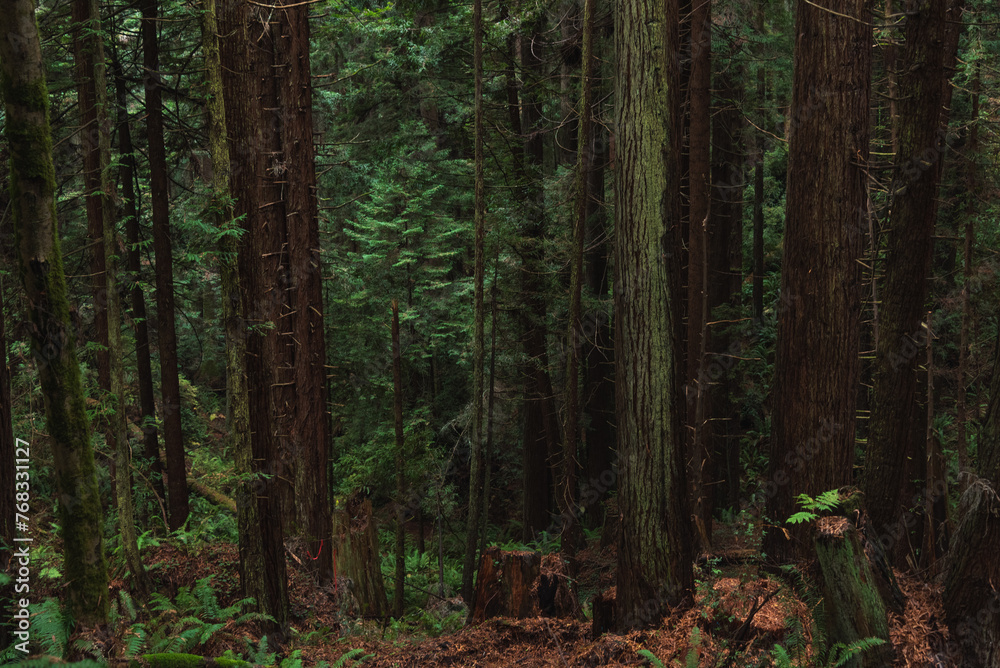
[{"xmin": 0, "ymin": 0, "xmax": 108, "ymax": 626}]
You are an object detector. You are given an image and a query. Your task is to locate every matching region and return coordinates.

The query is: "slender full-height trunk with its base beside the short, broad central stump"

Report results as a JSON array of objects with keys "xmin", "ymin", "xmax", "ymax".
[{"xmin": 462, "ymin": 0, "xmax": 486, "ymax": 609}]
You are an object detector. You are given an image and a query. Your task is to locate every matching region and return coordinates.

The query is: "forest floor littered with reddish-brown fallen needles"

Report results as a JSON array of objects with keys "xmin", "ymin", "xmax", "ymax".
[{"xmin": 78, "ymin": 520, "xmax": 947, "ymax": 668}]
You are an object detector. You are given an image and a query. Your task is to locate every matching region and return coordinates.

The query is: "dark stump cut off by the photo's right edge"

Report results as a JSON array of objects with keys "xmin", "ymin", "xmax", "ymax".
[{"xmin": 944, "ymin": 478, "xmax": 1000, "ymax": 668}]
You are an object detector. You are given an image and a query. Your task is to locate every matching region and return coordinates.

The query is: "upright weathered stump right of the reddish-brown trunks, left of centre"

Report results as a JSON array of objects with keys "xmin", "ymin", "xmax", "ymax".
[{"xmin": 333, "ymin": 494, "xmax": 389, "ymax": 617}]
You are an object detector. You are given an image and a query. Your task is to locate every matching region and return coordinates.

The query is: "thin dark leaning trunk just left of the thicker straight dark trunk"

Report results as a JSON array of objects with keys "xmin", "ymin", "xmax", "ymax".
[{"xmin": 114, "ymin": 61, "xmax": 166, "ymax": 506}]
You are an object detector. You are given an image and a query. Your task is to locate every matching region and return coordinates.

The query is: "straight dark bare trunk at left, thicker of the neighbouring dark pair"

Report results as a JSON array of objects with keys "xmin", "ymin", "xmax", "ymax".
[{"xmin": 142, "ymin": 0, "xmax": 188, "ymax": 530}]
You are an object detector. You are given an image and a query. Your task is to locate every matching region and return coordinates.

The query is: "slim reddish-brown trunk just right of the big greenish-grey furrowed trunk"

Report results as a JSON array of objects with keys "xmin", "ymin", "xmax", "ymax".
[{"xmin": 684, "ymin": 0, "xmax": 712, "ymax": 551}]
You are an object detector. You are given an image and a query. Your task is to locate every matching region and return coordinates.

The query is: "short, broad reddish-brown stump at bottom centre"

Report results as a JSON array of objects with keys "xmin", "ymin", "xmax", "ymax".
[{"xmin": 469, "ymin": 547, "xmax": 579, "ymax": 624}]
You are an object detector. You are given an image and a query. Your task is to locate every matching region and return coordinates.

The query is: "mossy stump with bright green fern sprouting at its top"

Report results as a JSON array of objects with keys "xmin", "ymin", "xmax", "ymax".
[{"xmin": 814, "ymin": 517, "xmax": 894, "ymax": 668}]
